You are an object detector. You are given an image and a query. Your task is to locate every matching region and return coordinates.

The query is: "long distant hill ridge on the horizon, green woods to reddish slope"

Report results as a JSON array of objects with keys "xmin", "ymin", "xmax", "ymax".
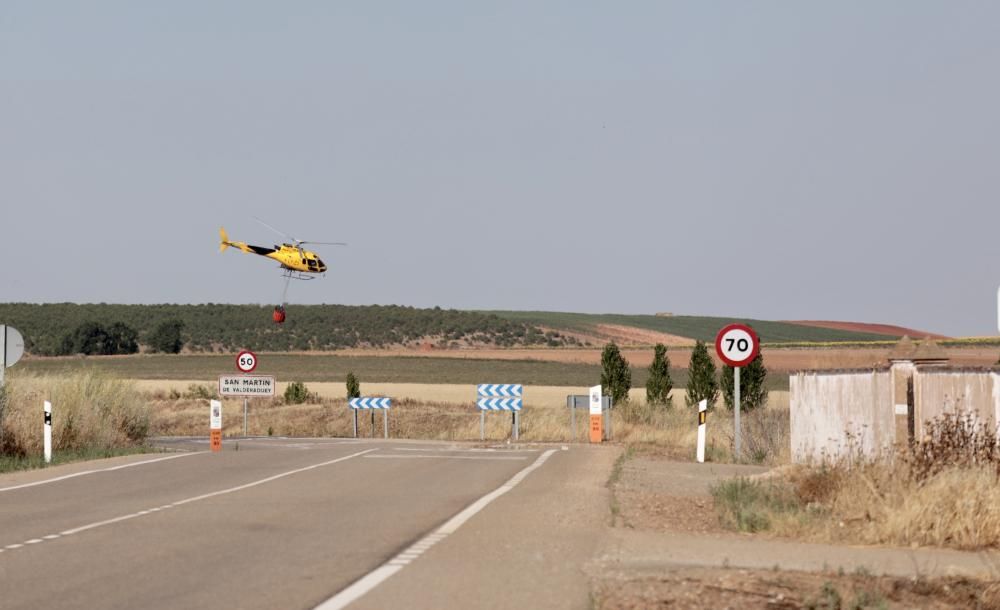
[{"xmin": 0, "ymin": 303, "xmax": 940, "ymax": 355}]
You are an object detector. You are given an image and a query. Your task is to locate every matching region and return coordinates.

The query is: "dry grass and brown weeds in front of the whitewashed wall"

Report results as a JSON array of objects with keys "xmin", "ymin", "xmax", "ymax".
[{"xmin": 715, "ymin": 415, "xmax": 1000, "ymax": 549}]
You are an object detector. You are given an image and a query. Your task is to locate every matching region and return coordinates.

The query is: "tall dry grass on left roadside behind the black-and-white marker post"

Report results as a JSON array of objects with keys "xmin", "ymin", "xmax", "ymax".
[{"xmin": 0, "ymin": 372, "xmax": 149, "ymax": 457}]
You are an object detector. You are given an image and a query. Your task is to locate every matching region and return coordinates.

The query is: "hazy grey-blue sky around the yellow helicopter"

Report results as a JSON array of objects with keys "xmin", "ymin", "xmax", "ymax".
[{"xmin": 0, "ymin": 0, "xmax": 1000, "ymax": 335}]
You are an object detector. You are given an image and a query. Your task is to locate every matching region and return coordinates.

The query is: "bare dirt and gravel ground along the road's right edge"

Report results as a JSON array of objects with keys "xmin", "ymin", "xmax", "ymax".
[{"xmin": 588, "ymin": 448, "xmax": 1000, "ymax": 608}]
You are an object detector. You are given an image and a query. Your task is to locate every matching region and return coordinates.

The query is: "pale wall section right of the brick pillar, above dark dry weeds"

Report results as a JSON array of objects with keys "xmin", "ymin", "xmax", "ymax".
[{"xmin": 913, "ymin": 367, "xmax": 1000, "ymax": 440}]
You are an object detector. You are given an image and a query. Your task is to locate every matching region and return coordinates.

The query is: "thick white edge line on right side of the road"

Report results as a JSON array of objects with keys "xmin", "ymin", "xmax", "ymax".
[{"xmin": 315, "ymin": 449, "xmax": 556, "ymax": 610}]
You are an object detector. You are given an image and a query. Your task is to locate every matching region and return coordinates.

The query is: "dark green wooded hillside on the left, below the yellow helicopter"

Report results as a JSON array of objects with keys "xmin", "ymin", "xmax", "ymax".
[{"xmin": 0, "ymin": 303, "xmax": 578, "ymax": 356}]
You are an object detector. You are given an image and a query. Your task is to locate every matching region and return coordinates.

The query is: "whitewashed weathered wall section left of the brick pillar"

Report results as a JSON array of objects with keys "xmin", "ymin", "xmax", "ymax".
[{"xmin": 789, "ymin": 370, "xmax": 896, "ymax": 463}]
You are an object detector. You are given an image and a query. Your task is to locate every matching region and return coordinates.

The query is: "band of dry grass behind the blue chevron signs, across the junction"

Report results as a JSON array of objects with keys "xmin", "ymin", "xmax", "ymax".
[{"xmin": 146, "ymin": 382, "xmax": 788, "ymax": 463}]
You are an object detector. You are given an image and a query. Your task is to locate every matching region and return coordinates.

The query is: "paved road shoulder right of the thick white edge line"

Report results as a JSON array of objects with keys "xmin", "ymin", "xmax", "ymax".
[{"xmin": 351, "ymin": 446, "xmax": 621, "ymax": 608}]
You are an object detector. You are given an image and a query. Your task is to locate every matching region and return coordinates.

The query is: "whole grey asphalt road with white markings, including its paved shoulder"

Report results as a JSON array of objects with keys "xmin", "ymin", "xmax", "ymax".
[{"xmin": 0, "ymin": 439, "xmax": 616, "ymax": 609}]
